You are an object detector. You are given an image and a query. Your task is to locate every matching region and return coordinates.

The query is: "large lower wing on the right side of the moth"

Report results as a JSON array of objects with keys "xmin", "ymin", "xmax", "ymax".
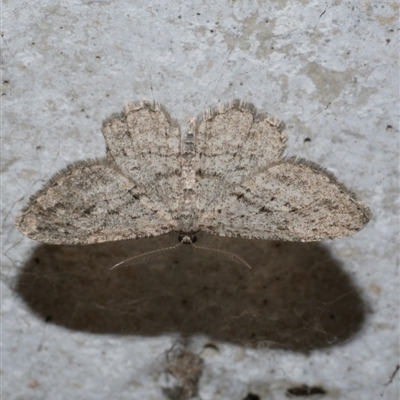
[{"xmin": 200, "ymin": 159, "xmax": 370, "ymax": 242}]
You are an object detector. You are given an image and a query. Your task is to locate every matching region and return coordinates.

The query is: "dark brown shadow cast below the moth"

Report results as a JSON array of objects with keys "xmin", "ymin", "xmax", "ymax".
[{"xmin": 15, "ymin": 234, "xmax": 365, "ymax": 351}]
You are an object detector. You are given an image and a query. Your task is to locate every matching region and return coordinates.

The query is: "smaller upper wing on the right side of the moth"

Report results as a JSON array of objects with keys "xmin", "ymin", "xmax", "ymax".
[{"xmin": 194, "ymin": 100, "xmax": 286, "ymax": 217}]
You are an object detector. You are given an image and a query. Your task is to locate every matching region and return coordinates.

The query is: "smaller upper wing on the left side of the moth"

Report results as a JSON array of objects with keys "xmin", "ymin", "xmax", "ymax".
[{"xmin": 103, "ymin": 101, "xmax": 181, "ymax": 218}]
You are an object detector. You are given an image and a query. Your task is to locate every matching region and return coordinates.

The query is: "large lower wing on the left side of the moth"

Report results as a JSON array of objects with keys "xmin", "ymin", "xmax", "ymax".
[{"xmin": 16, "ymin": 160, "xmax": 175, "ymax": 244}]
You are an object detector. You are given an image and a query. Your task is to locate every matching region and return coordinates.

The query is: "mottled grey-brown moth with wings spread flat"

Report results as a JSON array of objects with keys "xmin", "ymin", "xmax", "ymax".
[{"xmin": 16, "ymin": 100, "xmax": 371, "ymax": 245}]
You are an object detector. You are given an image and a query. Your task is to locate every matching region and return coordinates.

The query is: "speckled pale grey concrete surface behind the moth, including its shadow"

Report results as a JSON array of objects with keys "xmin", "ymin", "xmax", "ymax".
[{"xmin": 1, "ymin": 0, "xmax": 399, "ymax": 400}]
